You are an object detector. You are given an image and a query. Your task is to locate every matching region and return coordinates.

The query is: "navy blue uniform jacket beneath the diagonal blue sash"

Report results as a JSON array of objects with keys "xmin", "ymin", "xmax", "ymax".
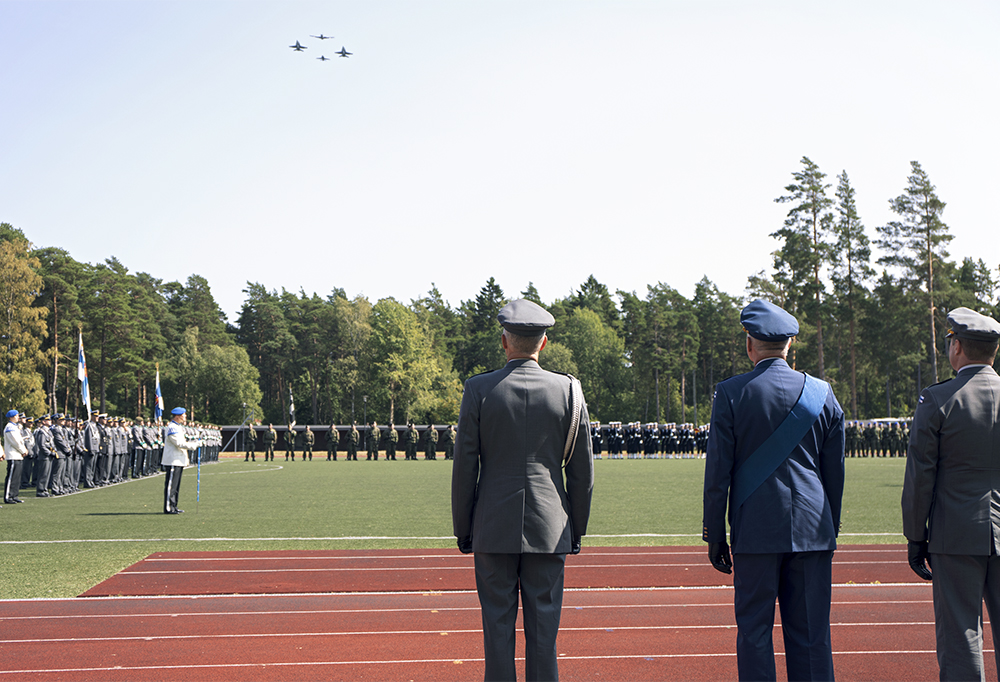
[{"xmin": 702, "ymin": 358, "xmax": 844, "ymax": 554}]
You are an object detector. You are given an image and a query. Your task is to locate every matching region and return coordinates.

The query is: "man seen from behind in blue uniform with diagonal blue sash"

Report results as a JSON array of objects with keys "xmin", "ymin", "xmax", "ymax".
[{"xmin": 702, "ymin": 300, "xmax": 844, "ymax": 680}]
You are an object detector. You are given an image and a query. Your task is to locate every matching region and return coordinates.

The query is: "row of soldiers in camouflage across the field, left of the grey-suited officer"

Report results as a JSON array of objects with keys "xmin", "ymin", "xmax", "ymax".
[{"xmin": 244, "ymin": 421, "xmax": 455, "ymax": 462}]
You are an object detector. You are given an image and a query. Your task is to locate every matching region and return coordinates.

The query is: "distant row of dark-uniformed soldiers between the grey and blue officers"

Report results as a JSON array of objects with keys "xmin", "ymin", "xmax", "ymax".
[{"xmin": 590, "ymin": 422, "xmax": 708, "ymax": 459}]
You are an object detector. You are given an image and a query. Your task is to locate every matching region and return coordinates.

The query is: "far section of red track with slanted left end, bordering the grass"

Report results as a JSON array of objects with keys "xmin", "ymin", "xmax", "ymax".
[{"xmin": 81, "ymin": 545, "xmax": 919, "ymax": 597}]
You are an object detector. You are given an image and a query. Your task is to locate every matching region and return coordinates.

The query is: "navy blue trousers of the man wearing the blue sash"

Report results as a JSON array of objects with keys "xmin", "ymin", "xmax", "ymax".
[{"xmin": 733, "ymin": 551, "xmax": 833, "ymax": 682}]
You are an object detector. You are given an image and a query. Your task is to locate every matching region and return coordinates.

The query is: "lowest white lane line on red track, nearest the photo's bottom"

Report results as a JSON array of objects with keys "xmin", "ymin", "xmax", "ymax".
[{"xmin": 0, "ymin": 649, "xmax": 956, "ymax": 675}]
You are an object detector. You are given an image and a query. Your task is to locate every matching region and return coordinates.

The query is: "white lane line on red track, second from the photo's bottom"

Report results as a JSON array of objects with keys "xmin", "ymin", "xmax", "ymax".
[{"xmin": 0, "ymin": 621, "xmax": 934, "ymax": 644}]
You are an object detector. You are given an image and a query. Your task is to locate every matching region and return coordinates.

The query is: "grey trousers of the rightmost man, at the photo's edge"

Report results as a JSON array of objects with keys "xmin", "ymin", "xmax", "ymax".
[{"xmin": 930, "ymin": 554, "xmax": 1000, "ymax": 680}]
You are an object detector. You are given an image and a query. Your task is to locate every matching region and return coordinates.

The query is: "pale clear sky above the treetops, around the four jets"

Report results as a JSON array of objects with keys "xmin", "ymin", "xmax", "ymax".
[{"xmin": 0, "ymin": 0, "xmax": 1000, "ymax": 319}]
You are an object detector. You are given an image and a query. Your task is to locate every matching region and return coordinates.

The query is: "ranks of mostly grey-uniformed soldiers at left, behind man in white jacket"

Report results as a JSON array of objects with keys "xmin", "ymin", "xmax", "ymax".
[{"xmin": 9, "ymin": 412, "xmax": 222, "ymax": 497}]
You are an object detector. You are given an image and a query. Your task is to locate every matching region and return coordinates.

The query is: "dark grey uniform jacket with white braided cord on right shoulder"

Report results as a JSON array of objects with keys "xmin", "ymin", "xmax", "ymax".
[{"xmin": 451, "ymin": 359, "xmax": 594, "ymax": 554}]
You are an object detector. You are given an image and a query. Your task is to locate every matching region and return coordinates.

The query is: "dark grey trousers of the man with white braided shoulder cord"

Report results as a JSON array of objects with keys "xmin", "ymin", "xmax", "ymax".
[{"xmin": 475, "ymin": 552, "xmax": 566, "ymax": 682}]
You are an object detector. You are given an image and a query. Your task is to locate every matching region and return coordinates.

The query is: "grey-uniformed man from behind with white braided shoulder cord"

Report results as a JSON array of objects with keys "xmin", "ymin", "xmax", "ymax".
[{"xmin": 451, "ymin": 300, "xmax": 594, "ymax": 680}]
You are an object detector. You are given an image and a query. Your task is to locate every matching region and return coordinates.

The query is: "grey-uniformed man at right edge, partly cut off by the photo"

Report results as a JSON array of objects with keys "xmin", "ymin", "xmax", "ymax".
[{"xmin": 902, "ymin": 308, "xmax": 1000, "ymax": 680}]
